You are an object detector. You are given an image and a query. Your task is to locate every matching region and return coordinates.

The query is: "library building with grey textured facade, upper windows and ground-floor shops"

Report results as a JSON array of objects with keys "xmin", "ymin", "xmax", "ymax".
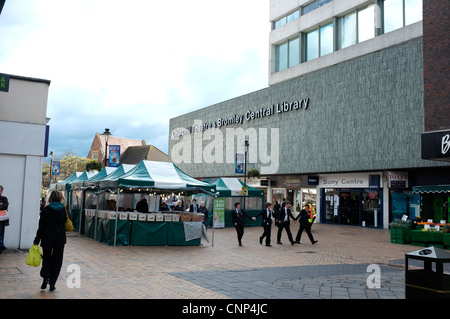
[{"xmin": 169, "ymin": 0, "xmax": 450, "ymax": 228}]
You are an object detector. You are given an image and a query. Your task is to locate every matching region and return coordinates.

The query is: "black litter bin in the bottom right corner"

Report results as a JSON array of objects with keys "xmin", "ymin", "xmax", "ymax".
[{"xmin": 405, "ymin": 247, "xmax": 450, "ymax": 299}]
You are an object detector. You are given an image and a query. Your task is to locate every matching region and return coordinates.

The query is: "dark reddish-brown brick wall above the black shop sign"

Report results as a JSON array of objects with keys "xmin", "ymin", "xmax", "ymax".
[{"xmin": 423, "ymin": 0, "xmax": 450, "ymax": 132}]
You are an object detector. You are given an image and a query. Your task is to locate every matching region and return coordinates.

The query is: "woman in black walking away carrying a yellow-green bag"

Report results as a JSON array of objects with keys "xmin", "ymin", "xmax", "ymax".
[{"xmin": 34, "ymin": 191, "xmax": 68, "ymax": 291}]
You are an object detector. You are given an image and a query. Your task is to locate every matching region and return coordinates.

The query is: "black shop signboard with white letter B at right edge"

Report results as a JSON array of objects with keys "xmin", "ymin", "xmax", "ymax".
[{"xmin": 422, "ymin": 130, "xmax": 450, "ymax": 161}]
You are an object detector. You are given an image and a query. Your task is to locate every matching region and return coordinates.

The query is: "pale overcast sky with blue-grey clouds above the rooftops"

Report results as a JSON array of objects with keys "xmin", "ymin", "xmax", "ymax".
[{"xmin": 0, "ymin": 0, "xmax": 270, "ymax": 160}]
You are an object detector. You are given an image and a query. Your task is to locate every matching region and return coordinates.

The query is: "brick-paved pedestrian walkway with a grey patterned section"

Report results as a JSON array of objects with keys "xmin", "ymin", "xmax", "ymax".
[{"xmin": 0, "ymin": 223, "xmax": 430, "ymax": 299}]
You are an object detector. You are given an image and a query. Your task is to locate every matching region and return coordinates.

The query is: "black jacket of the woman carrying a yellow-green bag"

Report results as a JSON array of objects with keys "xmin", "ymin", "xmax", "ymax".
[{"xmin": 34, "ymin": 202, "xmax": 67, "ymax": 247}]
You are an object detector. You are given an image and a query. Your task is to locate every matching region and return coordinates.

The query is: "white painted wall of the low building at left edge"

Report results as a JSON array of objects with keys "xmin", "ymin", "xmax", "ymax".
[{"xmin": 0, "ymin": 78, "xmax": 49, "ymax": 249}]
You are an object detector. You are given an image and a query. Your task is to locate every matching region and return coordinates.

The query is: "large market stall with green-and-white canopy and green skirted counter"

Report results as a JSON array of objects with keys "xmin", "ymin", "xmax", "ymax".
[{"xmin": 90, "ymin": 161, "xmax": 215, "ymax": 245}]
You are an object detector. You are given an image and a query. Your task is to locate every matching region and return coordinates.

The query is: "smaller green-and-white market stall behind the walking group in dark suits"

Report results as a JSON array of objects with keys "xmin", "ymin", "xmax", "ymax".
[{"xmin": 214, "ymin": 178, "xmax": 264, "ymax": 228}]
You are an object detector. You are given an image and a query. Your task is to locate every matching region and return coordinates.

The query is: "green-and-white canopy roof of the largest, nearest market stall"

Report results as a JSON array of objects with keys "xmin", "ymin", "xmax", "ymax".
[{"xmin": 116, "ymin": 161, "xmax": 215, "ymax": 193}]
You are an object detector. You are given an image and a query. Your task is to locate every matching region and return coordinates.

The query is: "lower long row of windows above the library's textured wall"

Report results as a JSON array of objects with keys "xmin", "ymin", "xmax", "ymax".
[{"xmin": 275, "ymin": 0, "xmax": 422, "ymax": 72}]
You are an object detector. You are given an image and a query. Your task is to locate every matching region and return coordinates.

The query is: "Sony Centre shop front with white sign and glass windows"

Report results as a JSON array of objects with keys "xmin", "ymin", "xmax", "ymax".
[{"xmin": 318, "ymin": 173, "xmax": 383, "ymax": 228}]
